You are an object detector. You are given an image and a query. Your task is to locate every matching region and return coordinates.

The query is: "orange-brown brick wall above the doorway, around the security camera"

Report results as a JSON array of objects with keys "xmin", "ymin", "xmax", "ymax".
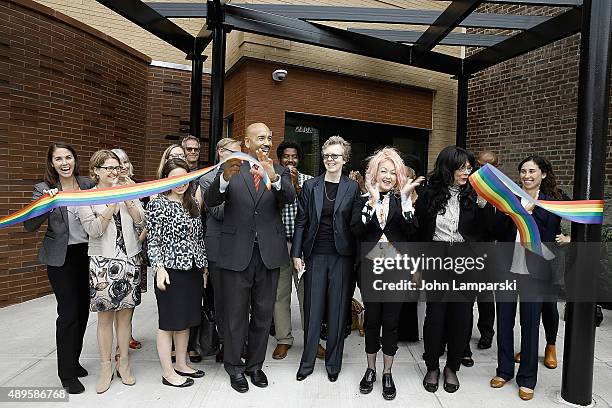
[{"xmin": 224, "ymin": 59, "xmax": 434, "ymax": 153}]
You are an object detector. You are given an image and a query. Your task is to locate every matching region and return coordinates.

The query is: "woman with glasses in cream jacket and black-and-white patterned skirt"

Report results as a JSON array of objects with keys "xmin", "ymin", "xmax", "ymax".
[{"xmin": 79, "ymin": 150, "xmax": 145, "ymax": 394}]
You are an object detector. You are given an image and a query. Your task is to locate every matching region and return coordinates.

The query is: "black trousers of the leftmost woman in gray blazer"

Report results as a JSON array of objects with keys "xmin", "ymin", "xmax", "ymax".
[{"xmin": 47, "ymin": 244, "xmax": 89, "ymax": 380}]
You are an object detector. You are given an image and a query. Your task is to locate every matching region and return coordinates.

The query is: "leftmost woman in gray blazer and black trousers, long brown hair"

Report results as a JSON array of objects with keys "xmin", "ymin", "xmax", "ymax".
[{"xmin": 24, "ymin": 143, "xmax": 94, "ymax": 394}]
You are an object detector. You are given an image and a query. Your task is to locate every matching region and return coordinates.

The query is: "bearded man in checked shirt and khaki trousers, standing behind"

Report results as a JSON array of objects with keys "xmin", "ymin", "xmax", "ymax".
[{"xmin": 272, "ymin": 140, "xmax": 325, "ymax": 360}]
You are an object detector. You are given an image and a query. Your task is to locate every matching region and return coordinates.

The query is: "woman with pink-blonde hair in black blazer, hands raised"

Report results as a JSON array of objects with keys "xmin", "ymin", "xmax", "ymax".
[{"xmin": 351, "ymin": 147, "xmax": 424, "ymax": 400}]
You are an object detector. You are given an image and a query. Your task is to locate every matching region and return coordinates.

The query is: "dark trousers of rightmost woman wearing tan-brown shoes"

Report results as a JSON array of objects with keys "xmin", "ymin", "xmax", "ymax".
[{"xmin": 496, "ymin": 301, "xmax": 542, "ymax": 389}]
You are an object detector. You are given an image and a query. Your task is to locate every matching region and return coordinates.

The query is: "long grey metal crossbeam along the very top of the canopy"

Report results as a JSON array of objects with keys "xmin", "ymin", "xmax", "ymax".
[{"xmin": 147, "ymin": 2, "xmax": 548, "ymax": 30}]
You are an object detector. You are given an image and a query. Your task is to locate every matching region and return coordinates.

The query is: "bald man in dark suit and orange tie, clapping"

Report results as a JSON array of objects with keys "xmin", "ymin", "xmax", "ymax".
[{"xmin": 204, "ymin": 123, "xmax": 295, "ymax": 392}]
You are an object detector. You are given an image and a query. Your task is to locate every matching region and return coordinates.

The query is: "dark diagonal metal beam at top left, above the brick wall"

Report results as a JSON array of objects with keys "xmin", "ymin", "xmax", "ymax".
[{"xmin": 97, "ymin": 0, "xmax": 195, "ymax": 54}]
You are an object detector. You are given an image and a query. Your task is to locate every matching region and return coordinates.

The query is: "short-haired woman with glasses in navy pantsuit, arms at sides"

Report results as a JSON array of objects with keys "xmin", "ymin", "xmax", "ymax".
[{"xmin": 291, "ymin": 136, "xmax": 359, "ymax": 382}]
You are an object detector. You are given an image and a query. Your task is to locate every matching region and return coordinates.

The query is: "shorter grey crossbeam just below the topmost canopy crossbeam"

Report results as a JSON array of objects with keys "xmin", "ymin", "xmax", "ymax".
[{"xmin": 348, "ymin": 27, "xmax": 510, "ymax": 47}]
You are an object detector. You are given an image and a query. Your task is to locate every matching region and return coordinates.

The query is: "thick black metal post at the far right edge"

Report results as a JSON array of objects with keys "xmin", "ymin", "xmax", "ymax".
[{"xmin": 561, "ymin": 0, "xmax": 612, "ymax": 406}]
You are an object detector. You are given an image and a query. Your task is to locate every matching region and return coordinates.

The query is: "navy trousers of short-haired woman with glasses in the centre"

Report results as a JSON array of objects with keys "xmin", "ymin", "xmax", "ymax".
[{"xmin": 298, "ymin": 254, "xmax": 353, "ymax": 375}]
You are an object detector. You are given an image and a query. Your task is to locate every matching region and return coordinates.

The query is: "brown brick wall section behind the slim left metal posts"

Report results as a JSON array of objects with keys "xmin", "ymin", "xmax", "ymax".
[{"xmin": 143, "ymin": 66, "xmax": 210, "ymax": 180}]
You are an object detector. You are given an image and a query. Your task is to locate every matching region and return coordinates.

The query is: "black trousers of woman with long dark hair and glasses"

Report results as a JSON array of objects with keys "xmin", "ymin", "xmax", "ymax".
[{"xmin": 423, "ymin": 300, "xmax": 472, "ymax": 371}]
